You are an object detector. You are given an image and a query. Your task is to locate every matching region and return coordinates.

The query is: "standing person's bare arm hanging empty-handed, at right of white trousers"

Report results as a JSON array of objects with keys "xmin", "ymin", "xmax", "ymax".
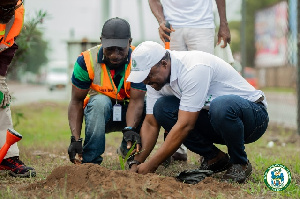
[{"xmin": 216, "ymin": 0, "xmax": 231, "ymax": 48}]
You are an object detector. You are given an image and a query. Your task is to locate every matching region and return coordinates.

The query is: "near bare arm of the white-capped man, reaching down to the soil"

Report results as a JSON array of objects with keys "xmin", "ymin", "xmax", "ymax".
[{"xmin": 138, "ymin": 110, "xmax": 199, "ymax": 174}]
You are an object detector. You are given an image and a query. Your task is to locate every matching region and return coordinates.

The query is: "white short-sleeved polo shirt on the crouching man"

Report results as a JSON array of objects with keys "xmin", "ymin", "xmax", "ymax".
[{"xmin": 146, "ymin": 51, "xmax": 267, "ymax": 114}]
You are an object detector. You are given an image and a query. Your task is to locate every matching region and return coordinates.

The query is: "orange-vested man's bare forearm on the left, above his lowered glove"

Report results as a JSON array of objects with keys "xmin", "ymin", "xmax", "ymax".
[{"xmin": 68, "ymin": 85, "xmax": 89, "ymax": 140}]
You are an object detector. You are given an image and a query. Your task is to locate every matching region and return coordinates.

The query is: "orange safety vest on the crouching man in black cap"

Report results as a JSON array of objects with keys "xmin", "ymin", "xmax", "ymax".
[{"xmin": 81, "ymin": 45, "xmax": 135, "ymax": 107}]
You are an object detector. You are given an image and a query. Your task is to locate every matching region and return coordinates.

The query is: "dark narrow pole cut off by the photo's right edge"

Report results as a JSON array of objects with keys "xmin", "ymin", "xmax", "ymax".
[{"xmin": 296, "ymin": 1, "xmax": 300, "ymax": 135}]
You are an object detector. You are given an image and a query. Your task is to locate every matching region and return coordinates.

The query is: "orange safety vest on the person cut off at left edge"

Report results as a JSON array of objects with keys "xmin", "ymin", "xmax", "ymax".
[{"xmin": 0, "ymin": 0, "xmax": 24, "ymax": 52}]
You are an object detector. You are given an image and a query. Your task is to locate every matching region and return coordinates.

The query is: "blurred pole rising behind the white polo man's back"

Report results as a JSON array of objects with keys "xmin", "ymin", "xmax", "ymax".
[{"xmin": 240, "ymin": 0, "xmax": 247, "ymax": 77}]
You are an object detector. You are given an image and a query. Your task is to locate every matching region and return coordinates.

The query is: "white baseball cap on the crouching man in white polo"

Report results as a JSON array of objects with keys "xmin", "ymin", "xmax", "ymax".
[{"xmin": 127, "ymin": 41, "xmax": 166, "ymax": 83}]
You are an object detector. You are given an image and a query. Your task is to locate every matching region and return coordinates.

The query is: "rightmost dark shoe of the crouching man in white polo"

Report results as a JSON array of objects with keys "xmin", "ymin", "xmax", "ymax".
[{"xmin": 223, "ymin": 160, "xmax": 252, "ymax": 183}]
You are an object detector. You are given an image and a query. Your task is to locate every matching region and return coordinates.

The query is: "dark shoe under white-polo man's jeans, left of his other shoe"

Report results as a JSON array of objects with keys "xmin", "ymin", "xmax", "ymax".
[{"xmin": 199, "ymin": 152, "xmax": 231, "ymax": 173}]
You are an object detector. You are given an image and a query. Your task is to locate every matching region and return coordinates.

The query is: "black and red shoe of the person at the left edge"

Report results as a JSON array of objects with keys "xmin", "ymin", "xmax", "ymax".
[{"xmin": 0, "ymin": 156, "xmax": 36, "ymax": 178}]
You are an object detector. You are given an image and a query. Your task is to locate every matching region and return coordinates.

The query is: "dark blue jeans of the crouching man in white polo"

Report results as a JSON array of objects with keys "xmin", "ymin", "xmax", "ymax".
[{"xmin": 153, "ymin": 95, "xmax": 269, "ymax": 164}]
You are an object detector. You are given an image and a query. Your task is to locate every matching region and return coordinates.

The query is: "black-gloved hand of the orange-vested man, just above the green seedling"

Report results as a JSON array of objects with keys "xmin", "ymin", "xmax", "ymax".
[{"xmin": 122, "ymin": 127, "xmax": 142, "ymax": 152}]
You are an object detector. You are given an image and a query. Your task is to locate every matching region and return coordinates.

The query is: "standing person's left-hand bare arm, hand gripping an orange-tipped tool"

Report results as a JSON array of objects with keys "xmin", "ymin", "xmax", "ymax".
[{"xmin": 149, "ymin": 0, "xmax": 175, "ymax": 42}]
